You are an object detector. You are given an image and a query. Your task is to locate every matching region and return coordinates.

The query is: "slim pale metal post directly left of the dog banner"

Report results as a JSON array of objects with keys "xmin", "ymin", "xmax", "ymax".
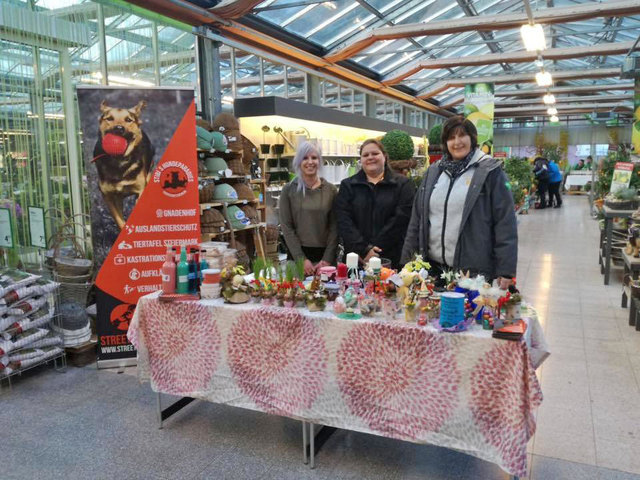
[{"xmin": 60, "ymin": 49, "xmax": 85, "ymax": 238}]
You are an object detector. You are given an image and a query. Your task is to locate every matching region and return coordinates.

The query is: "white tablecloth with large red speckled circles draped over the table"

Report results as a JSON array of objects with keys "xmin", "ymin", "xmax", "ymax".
[{"xmin": 128, "ymin": 294, "xmax": 548, "ymax": 476}]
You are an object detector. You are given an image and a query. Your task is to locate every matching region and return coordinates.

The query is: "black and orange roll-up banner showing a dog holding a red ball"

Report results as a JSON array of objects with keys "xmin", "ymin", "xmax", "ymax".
[{"xmin": 78, "ymin": 87, "xmax": 200, "ymax": 366}]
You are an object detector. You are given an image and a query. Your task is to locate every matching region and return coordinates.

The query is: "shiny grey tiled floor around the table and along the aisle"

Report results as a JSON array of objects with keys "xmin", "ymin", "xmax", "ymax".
[{"xmin": 0, "ymin": 197, "xmax": 640, "ymax": 480}]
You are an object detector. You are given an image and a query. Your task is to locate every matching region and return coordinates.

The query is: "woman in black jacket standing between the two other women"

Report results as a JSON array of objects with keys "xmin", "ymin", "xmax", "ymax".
[{"xmin": 334, "ymin": 139, "xmax": 415, "ymax": 268}]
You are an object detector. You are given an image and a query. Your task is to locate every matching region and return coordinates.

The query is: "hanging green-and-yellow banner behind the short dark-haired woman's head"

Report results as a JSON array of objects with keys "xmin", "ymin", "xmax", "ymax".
[{"xmin": 464, "ymin": 83, "xmax": 494, "ymax": 154}]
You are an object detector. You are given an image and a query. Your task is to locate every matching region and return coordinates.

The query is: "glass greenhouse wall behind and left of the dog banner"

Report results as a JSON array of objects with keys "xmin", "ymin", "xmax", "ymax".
[{"xmin": 0, "ymin": 0, "xmax": 197, "ymax": 252}]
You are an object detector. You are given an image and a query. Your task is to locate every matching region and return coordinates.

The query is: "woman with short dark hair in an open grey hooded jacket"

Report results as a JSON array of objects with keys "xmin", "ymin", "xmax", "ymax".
[{"xmin": 402, "ymin": 117, "xmax": 518, "ymax": 288}]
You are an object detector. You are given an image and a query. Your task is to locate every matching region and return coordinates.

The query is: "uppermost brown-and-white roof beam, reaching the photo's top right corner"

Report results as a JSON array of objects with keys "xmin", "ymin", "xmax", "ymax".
[{"xmin": 325, "ymin": 0, "xmax": 640, "ymax": 62}]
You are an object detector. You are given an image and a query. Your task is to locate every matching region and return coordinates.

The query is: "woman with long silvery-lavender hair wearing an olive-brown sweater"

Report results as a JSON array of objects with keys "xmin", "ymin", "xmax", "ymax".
[{"xmin": 279, "ymin": 142, "xmax": 338, "ymax": 275}]
